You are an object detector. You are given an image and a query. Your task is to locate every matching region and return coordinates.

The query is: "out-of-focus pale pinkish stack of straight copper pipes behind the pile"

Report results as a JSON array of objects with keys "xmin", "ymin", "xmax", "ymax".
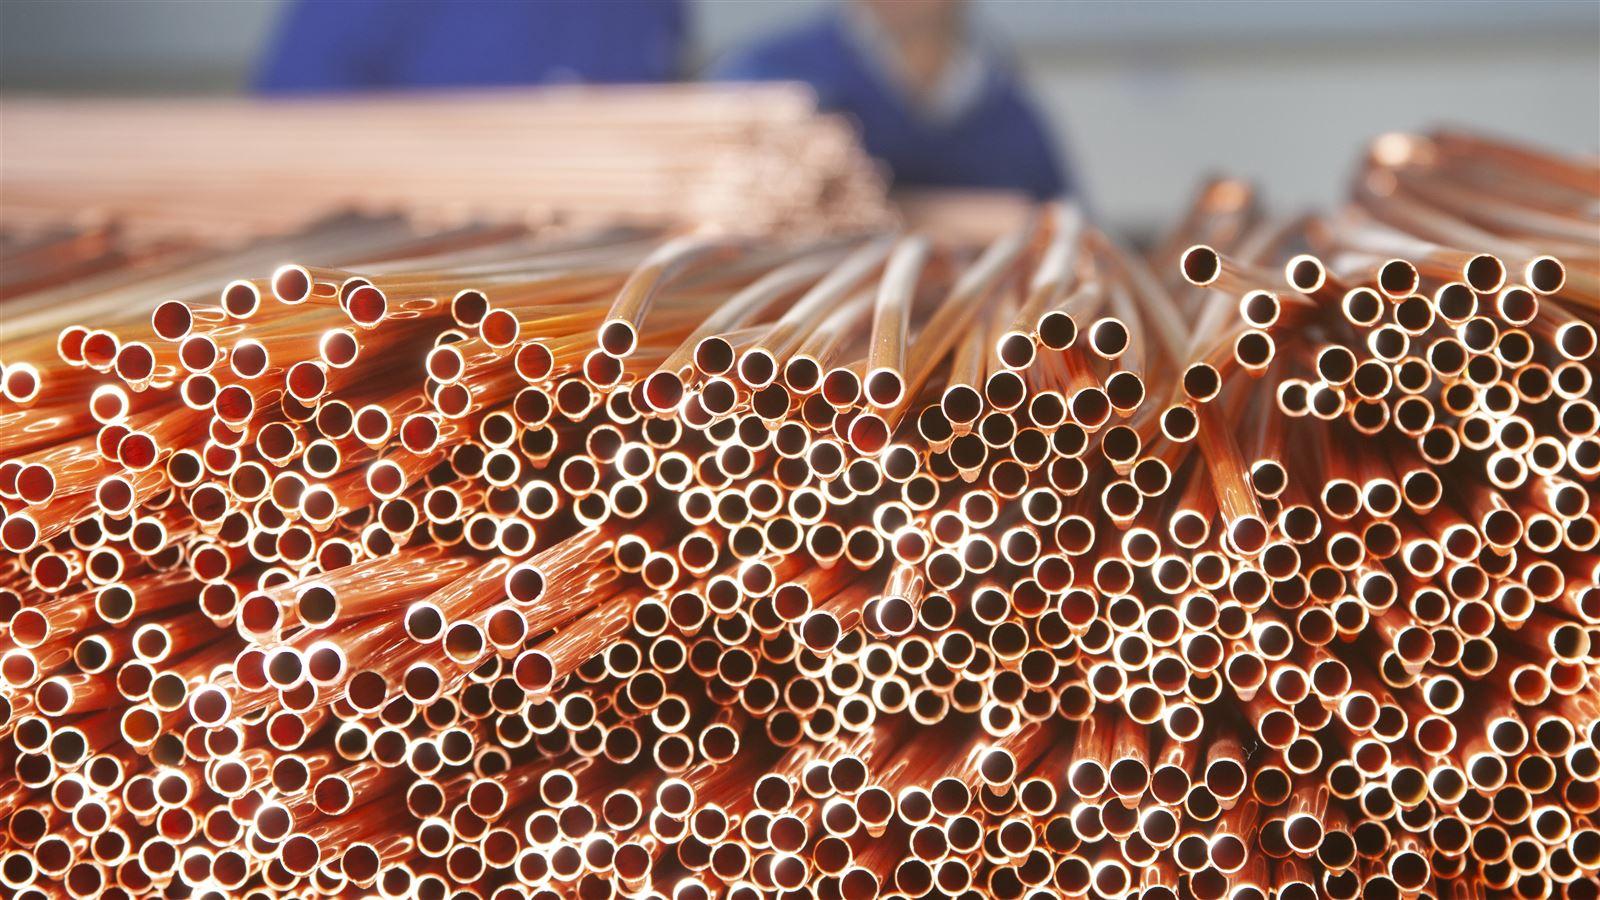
[{"xmin": 0, "ymin": 83, "xmax": 888, "ymax": 240}]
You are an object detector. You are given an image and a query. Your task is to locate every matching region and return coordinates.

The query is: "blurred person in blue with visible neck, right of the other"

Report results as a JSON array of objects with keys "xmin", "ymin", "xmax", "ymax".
[{"xmin": 712, "ymin": 0, "xmax": 1074, "ymax": 199}]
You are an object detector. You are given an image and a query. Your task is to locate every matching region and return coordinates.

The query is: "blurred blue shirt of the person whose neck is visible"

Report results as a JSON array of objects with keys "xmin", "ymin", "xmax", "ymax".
[{"xmin": 712, "ymin": 14, "xmax": 1072, "ymax": 199}]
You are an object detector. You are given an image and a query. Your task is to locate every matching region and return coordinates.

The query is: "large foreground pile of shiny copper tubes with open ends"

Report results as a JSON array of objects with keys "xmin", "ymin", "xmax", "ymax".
[{"xmin": 0, "ymin": 133, "xmax": 1600, "ymax": 900}]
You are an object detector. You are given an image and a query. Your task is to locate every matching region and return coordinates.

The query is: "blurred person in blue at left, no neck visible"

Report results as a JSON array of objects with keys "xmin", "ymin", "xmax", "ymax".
[{"xmin": 256, "ymin": 0, "xmax": 685, "ymax": 93}]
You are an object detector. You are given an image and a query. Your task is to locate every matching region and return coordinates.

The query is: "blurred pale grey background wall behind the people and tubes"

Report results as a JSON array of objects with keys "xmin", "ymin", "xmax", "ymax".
[{"xmin": 0, "ymin": 0, "xmax": 1600, "ymax": 234}]
